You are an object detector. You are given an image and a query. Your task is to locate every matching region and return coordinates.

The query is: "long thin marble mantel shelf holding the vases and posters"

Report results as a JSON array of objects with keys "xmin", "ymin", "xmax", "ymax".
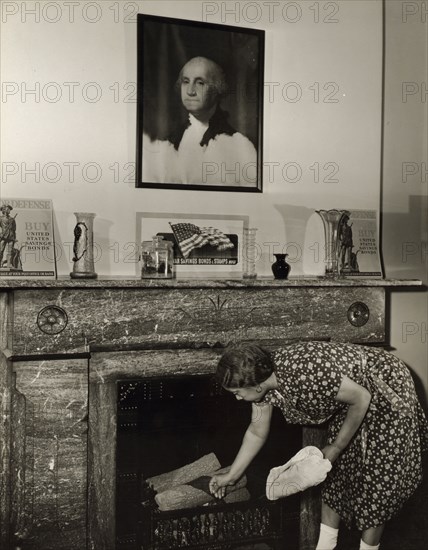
[{"xmin": 0, "ymin": 277, "xmax": 422, "ymax": 291}]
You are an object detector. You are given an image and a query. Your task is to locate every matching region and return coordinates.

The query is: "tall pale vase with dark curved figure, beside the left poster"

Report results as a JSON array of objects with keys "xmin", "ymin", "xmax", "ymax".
[{"xmin": 70, "ymin": 212, "xmax": 97, "ymax": 279}]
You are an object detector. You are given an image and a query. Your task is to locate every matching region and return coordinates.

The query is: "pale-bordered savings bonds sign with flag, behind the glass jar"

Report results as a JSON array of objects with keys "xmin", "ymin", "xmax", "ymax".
[{"xmin": 136, "ymin": 212, "xmax": 249, "ymax": 278}]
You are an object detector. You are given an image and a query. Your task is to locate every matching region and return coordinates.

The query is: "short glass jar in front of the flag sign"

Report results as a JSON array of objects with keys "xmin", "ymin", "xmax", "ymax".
[{"xmin": 141, "ymin": 235, "xmax": 174, "ymax": 279}]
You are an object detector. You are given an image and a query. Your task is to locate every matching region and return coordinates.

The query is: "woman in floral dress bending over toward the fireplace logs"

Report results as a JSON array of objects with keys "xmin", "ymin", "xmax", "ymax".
[{"xmin": 210, "ymin": 342, "xmax": 428, "ymax": 550}]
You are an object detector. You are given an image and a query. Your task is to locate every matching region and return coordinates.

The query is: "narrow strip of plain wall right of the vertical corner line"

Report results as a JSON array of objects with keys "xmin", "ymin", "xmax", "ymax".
[{"xmin": 382, "ymin": 1, "xmax": 428, "ymax": 404}]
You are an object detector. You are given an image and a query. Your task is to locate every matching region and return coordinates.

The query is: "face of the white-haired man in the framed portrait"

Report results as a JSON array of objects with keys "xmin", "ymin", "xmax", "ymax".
[{"xmin": 180, "ymin": 57, "xmax": 219, "ymax": 118}]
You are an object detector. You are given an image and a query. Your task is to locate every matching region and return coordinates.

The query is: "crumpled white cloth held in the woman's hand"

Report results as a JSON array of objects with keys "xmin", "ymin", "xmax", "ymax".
[{"xmin": 266, "ymin": 445, "xmax": 331, "ymax": 500}]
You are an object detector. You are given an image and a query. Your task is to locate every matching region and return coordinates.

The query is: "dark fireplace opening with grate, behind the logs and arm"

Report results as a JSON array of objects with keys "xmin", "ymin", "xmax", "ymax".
[{"xmin": 116, "ymin": 375, "xmax": 302, "ymax": 550}]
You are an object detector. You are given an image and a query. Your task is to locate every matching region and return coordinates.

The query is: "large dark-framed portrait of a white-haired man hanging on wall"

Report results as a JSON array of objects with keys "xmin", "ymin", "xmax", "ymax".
[{"xmin": 136, "ymin": 14, "xmax": 265, "ymax": 193}]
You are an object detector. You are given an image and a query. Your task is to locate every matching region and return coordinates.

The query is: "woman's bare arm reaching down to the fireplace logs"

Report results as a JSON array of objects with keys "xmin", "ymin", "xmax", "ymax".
[{"xmin": 210, "ymin": 403, "xmax": 272, "ymax": 498}]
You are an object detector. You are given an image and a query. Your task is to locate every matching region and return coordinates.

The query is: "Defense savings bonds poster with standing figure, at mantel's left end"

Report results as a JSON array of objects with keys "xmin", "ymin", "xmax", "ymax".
[{"xmin": 0, "ymin": 197, "xmax": 56, "ymax": 279}]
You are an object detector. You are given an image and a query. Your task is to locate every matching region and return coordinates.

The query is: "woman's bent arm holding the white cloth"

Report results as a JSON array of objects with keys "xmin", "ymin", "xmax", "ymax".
[{"xmin": 323, "ymin": 376, "xmax": 371, "ymax": 462}]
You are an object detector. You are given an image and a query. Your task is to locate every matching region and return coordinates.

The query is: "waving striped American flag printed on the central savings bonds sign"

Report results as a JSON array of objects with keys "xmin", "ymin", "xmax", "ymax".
[{"xmin": 169, "ymin": 223, "xmax": 235, "ymax": 258}]
